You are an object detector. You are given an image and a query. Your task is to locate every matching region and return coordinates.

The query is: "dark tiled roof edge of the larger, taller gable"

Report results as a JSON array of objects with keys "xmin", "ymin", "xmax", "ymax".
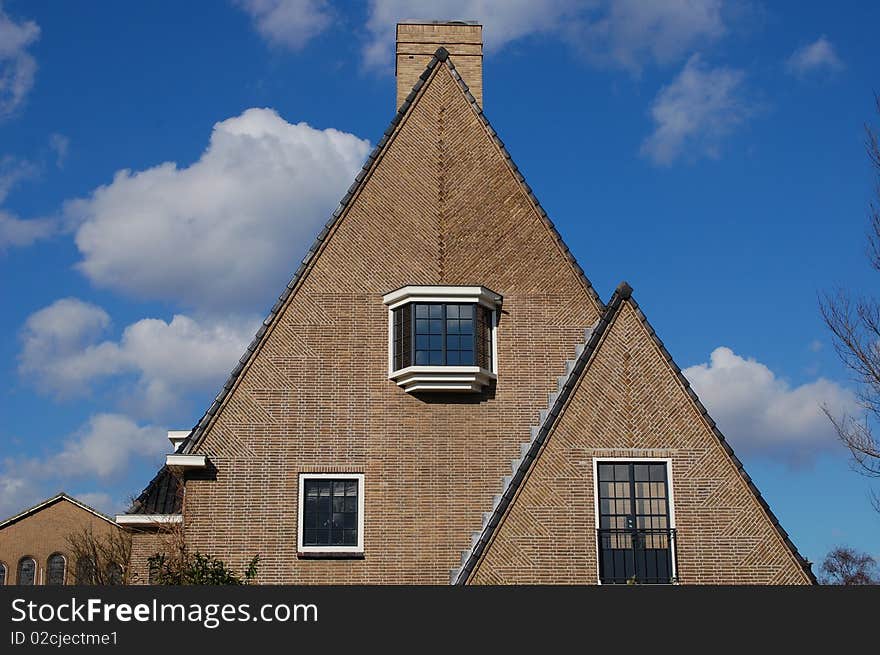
[{"xmin": 130, "ymin": 47, "xmax": 604, "ymax": 513}]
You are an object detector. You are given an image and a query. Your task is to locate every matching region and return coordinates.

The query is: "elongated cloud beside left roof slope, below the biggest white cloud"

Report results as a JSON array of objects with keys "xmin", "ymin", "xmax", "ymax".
[{"xmin": 19, "ymin": 298, "xmax": 257, "ymax": 418}]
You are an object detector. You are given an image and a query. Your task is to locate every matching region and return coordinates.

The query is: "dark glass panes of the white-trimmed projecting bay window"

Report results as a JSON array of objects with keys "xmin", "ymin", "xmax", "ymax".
[{"xmin": 393, "ymin": 303, "xmax": 492, "ymax": 370}]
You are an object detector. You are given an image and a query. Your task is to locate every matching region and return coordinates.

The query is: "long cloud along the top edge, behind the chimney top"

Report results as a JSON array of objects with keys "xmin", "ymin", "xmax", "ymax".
[{"xmin": 365, "ymin": 0, "xmax": 726, "ymax": 73}]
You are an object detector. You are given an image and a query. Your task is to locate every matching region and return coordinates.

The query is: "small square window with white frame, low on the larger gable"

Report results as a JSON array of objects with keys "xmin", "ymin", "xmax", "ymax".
[{"xmin": 297, "ymin": 473, "xmax": 364, "ymax": 554}]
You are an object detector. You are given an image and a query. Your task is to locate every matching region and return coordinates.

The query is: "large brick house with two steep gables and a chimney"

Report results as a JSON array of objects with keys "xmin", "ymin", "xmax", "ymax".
[{"xmin": 117, "ymin": 22, "xmax": 815, "ymax": 584}]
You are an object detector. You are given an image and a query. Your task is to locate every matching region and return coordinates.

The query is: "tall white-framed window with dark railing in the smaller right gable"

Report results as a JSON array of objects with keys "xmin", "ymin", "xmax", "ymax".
[{"xmin": 596, "ymin": 460, "xmax": 675, "ymax": 584}]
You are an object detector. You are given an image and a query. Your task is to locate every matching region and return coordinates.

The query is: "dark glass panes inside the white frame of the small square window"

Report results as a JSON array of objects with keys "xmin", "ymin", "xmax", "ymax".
[{"xmin": 303, "ymin": 478, "xmax": 359, "ymax": 546}]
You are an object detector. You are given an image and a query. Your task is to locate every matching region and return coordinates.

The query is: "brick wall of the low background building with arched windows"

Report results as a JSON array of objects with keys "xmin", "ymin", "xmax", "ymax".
[{"xmin": 0, "ymin": 498, "xmax": 119, "ymax": 585}]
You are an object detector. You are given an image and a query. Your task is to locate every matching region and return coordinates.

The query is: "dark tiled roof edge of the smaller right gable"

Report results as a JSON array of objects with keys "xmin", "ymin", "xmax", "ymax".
[{"xmin": 452, "ymin": 282, "xmax": 817, "ymax": 585}]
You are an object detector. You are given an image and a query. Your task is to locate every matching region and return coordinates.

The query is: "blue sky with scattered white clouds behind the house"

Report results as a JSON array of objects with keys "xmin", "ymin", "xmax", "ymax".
[{"xmin": 0, "ymin": 0, "xmax": 880, "ymax": 562}]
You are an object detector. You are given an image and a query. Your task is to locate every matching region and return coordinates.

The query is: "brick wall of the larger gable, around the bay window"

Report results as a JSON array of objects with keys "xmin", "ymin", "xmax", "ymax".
[{"xmin": 166, "ymin": 65, "xmax": 598, "ymax": 583}]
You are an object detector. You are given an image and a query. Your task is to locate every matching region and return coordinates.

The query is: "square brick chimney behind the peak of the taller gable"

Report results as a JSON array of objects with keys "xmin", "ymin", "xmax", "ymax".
[{"xmin": 397, "ymin": 20, "xmax": 483, "ymax": 107}]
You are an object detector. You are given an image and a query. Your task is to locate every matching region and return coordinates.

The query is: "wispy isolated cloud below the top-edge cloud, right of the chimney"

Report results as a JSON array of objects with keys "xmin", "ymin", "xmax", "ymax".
[{"xmin": 641, "ymin": 55, "xmax": 755, "ymax": 165}]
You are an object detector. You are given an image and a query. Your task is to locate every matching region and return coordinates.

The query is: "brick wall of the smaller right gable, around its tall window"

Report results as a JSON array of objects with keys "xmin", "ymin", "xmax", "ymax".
[{"xmin": 471, "ymin": 301, "xmax": 810, "ymax": 584}]
